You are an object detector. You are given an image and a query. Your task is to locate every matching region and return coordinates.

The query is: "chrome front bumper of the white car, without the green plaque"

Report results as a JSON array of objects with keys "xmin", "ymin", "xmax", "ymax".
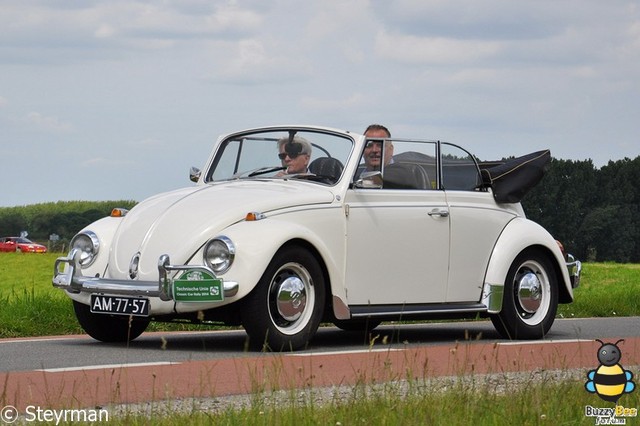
[{"xmin": 52, "ymin": 249, "xmax": 238, "ymax": 301}]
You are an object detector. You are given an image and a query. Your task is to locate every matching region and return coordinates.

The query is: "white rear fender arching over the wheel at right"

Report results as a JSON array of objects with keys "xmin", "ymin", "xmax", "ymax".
[{"xmin": 483, "ymin": 217, "xmax": 573, "ymax": 313}]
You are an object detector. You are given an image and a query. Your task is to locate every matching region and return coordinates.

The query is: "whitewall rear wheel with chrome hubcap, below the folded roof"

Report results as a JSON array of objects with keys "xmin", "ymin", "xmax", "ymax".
[{"xmin": 491, "ymin": 250, "xmax": 558, "ymax": 339}]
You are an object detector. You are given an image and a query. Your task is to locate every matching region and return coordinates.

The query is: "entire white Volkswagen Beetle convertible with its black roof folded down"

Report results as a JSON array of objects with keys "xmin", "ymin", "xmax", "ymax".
[{"xmin": 53, "ymin": 126, "xmax": 580, "ymax": 350}]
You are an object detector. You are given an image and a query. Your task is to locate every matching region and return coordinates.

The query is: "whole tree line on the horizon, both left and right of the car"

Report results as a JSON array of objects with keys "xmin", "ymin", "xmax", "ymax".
[{"xmin": 0, "ymin": 156, "xmax": 640, "ymax": 263}]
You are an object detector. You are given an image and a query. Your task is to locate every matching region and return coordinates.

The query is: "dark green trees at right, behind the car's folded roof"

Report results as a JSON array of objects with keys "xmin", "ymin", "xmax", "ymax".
[{"xmin": 522, "ymin": 156, "xmax": 640, "ymax": 263}]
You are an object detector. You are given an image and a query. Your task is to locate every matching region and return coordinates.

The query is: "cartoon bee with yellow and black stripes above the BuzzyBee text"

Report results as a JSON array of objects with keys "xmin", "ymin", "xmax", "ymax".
[{"xmin": 584, "ymin": 339, "xmax": 636, "ymax": 404}]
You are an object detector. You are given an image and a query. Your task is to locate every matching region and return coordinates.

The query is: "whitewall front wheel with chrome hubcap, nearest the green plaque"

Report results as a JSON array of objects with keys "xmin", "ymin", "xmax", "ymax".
[{"xmin": 242, "ymin": 246, "xmax": 325, "ymax": 351}]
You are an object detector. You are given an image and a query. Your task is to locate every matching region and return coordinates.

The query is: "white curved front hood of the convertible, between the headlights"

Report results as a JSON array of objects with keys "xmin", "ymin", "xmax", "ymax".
[{"xmin": 109, "ymin": 180, "xmax": 334, "ymax": 279}]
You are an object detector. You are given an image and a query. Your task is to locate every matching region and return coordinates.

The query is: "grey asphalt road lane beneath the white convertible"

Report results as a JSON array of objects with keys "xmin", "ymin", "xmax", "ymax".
[{"xmin": 0, "ymin": 317, "xmax": 640, "ymax": 373}]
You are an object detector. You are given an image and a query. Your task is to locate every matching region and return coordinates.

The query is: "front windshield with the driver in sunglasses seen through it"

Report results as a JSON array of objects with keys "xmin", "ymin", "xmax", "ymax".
[{"xmin": 205, "ymin": 129, "xmax": 353, "ymax": 185}]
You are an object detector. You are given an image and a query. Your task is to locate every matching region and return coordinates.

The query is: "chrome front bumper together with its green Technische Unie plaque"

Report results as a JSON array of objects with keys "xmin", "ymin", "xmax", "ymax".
[{"xmin": 53, "ymin": 249, "xmax": 238, "ymax": 302}]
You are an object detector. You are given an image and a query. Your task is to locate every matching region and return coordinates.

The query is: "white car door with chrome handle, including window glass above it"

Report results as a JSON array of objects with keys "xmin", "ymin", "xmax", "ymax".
[{"xmin": 345, "ymin": 142, "xmax": 449, "ymax": 305}]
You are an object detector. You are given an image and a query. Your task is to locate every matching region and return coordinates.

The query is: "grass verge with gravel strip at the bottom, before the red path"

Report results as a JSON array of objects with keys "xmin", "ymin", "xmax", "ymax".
[{"xmin": 111, "ymin": 371, "xmax": 640, "ymax": 425}]
